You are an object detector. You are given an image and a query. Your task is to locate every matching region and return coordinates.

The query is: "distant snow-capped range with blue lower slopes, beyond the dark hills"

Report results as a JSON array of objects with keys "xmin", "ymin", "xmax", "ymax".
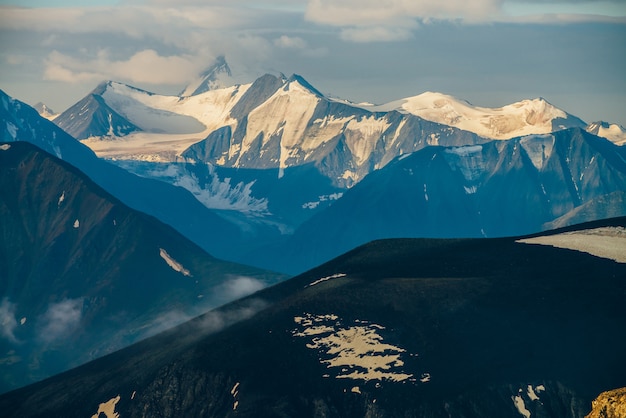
[{"xmin": 37, "ymin": 64, "xmax": 626, "ymax": 273}]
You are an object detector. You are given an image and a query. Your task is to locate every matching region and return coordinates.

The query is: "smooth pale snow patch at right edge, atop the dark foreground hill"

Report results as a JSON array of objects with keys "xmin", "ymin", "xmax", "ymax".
[{"xmin": 516, "ymin": 227, "xmax": 626, "ymax": 263}]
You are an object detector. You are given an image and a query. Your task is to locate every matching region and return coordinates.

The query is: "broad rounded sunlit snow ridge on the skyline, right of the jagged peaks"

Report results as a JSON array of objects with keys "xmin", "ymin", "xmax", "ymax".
[{"xmin": 354, "ymin": 92, "xmax": 583, "ymax": 139}]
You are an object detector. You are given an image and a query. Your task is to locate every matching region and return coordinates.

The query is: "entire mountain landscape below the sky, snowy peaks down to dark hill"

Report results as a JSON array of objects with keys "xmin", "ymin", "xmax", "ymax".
[{"xmin": 0, "ymin": 57, "xmax": 626, "ymax": 417}]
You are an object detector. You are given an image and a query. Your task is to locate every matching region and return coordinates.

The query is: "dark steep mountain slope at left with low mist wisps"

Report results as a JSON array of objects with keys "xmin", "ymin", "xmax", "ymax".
[{"xmin": 0, "ymin": 142, "xmax": 281, "ymax": 391}]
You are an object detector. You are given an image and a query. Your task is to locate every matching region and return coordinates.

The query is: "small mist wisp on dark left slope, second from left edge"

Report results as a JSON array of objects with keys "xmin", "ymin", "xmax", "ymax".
[{"xmin": 39, "ymin": 298, "xmax": 83, "ymax": 343}]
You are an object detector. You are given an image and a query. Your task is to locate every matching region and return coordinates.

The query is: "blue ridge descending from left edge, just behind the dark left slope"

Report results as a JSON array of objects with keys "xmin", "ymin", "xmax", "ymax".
[{"xmin": 0, "ymin": 91, "xmax": 258, "ymax": 258}]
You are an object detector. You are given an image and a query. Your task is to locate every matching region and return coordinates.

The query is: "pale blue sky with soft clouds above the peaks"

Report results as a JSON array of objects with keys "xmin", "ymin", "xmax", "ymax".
[{"xmin": 0, "ymin": 0, "xmax": 626, "ymax": 126}]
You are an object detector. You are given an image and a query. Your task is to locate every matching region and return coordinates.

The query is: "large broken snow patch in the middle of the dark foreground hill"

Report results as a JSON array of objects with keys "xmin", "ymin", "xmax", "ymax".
[{"xmin": 293, "ymin": 314, "xmax": 413, "ymax": 382}]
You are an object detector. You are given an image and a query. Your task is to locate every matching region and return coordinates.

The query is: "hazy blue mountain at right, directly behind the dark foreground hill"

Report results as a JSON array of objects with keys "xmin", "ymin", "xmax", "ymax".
[{"xmin": 264, "ymin": 128, "xmax": 626, "ymax": 271}]
